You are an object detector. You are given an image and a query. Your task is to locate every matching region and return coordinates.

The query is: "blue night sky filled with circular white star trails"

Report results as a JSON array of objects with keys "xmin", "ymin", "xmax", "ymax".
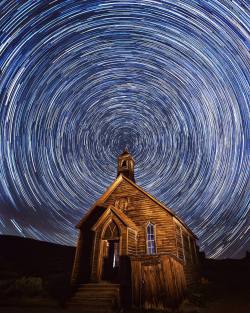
[{"xmin": 0, "ymin": 0, "xmax": 250, "ymax": 258}]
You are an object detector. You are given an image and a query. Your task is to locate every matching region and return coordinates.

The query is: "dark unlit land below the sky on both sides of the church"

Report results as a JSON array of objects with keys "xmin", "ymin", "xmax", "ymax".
[{"xmin": 0, "ymin": 236, "xmax": 250, "ymax": 313}]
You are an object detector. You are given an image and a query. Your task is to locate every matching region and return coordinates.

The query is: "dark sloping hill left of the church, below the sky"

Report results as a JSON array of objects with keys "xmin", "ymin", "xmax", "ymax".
[{"xmin": 0, "ymin": 235, "xmax": 75, "ymax": 279}]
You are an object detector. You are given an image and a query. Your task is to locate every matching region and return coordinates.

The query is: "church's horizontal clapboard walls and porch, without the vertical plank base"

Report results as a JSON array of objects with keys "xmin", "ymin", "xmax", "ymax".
[{"xmin": 72, "ymin": 173, "xmax": 199, "ymax": 292}]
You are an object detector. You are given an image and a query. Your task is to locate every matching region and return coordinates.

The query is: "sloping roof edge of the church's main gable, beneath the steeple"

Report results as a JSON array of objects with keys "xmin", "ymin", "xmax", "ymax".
[{"xmin": 76, "ymin": 174, "xmax": 197, "ymax": 239}]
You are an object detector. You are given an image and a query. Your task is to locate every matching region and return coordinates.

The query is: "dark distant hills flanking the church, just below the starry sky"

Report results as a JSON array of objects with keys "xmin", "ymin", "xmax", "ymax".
[{"xmin": 0, "ymin": 235, "xmax": 250, "ymax": 284}]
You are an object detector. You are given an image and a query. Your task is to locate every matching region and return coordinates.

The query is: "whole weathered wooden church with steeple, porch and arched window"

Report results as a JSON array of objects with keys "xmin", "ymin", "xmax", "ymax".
[{"xmin": 72, "ymin": 149, "xmax": 199, "ymax": 309}]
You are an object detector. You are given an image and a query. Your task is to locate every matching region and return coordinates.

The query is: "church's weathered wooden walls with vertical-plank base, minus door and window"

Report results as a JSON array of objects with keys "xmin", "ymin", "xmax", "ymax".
[{"xmin": 72, "ymin": 176, "xmax": 199, "ymax": 309}]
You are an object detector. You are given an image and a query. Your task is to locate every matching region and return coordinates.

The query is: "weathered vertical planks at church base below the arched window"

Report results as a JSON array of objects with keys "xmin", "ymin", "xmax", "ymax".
[{"xmin": 131, "ymin": 255, "xmax": 186, "ymax": 309}]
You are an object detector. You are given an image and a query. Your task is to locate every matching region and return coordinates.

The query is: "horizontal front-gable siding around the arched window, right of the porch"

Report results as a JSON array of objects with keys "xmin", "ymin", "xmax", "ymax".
[{"xmin": 104, "ymin": 181, "xmax": 177, "ymax": 255}]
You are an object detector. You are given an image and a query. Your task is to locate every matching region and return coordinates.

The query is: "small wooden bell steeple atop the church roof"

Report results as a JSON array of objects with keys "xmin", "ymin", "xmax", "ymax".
[{"xmin": 117, "ymin": 147, "xmax": 135, "ymax": 182}]
